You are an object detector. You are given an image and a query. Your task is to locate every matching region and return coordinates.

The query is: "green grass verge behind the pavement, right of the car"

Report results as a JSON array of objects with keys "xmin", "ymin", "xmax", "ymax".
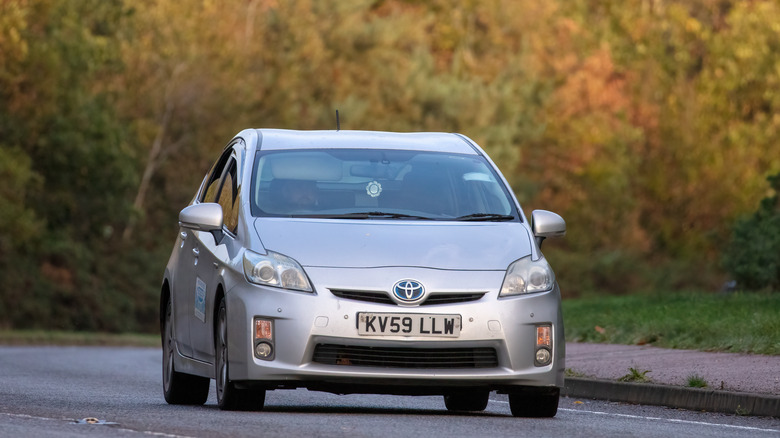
[{"xmin": 563, "ymin": 292, "xmax": 780, "ymax": 355}]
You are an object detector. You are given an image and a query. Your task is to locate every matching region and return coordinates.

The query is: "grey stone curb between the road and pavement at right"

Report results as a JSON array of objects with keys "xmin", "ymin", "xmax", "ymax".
[{"xmin": 561, "ymin": 377, "xmax": 780, "ymax": 418}]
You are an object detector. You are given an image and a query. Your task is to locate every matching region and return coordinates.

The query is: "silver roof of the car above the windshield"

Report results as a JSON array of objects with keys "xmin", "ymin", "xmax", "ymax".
[{"xmin": 255, "ymin": 129, "xmax": 481, "ymax": 155}]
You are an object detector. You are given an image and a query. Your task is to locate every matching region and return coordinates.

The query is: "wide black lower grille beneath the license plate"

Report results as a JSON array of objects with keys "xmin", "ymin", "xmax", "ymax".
[{"xmin": 312, "ymin": 344, "xmax": 498, "ymax": 368}]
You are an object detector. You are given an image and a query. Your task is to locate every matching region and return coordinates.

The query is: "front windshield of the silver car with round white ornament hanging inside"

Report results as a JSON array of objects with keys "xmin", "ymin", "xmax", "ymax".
[{"xmin": 251, "ymin": 149, "xmax": 519, "ymax": 221}]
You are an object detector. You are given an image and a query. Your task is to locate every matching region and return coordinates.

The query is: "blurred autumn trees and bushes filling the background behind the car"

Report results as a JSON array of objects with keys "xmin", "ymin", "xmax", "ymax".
[{"xmin": 0, "ymin": 0, "xmax": 780, "ymax": 334}]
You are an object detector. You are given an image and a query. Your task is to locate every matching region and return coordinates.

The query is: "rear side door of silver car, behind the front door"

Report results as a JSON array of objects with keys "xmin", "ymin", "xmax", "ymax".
[{"xmin": 172, "ymin": 145, "xmax": 230, "ymax": 357}]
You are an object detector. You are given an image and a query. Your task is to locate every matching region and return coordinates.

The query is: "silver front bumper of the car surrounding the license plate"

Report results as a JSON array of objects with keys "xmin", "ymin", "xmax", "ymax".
[{"xmin": 222, "ymin": 269, "xmax": 565, "ymax": 394}]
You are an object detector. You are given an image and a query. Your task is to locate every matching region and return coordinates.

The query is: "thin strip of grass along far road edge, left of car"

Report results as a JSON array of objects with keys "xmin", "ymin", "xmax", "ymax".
[{"xmin": 0, "ymin": 330, "xmax": 160, "ymax": 347}]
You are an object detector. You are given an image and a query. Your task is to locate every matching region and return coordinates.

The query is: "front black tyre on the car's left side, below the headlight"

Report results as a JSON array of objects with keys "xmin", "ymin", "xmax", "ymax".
[{"xmin": 214, "ymin": 298, "xmax": 265, "ymax": 411}]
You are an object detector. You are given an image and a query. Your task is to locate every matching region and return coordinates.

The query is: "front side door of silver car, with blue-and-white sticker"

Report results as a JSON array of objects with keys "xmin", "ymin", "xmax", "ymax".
[{"xmin": 190, "ymin": 145, "xmax": 241, "ymax": 362}]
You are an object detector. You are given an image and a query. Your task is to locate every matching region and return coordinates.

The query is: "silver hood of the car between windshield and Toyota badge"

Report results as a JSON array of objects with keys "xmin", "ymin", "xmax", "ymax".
[{"xmin": 255, "ymin": 218, "xmax": 531, "ymax": 270}]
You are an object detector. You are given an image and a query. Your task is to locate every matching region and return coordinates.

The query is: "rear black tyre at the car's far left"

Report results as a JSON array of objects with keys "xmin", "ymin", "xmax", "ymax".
[{"xmin": 162, "ymin": 299, "xmax": 211, "ymax": 405}]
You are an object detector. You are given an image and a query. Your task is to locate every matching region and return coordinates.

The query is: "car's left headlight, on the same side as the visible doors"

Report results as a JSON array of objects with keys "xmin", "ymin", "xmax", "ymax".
[{"xmin": 244, "ymin": 251, "xmax": 312, "ymax": 292}]
